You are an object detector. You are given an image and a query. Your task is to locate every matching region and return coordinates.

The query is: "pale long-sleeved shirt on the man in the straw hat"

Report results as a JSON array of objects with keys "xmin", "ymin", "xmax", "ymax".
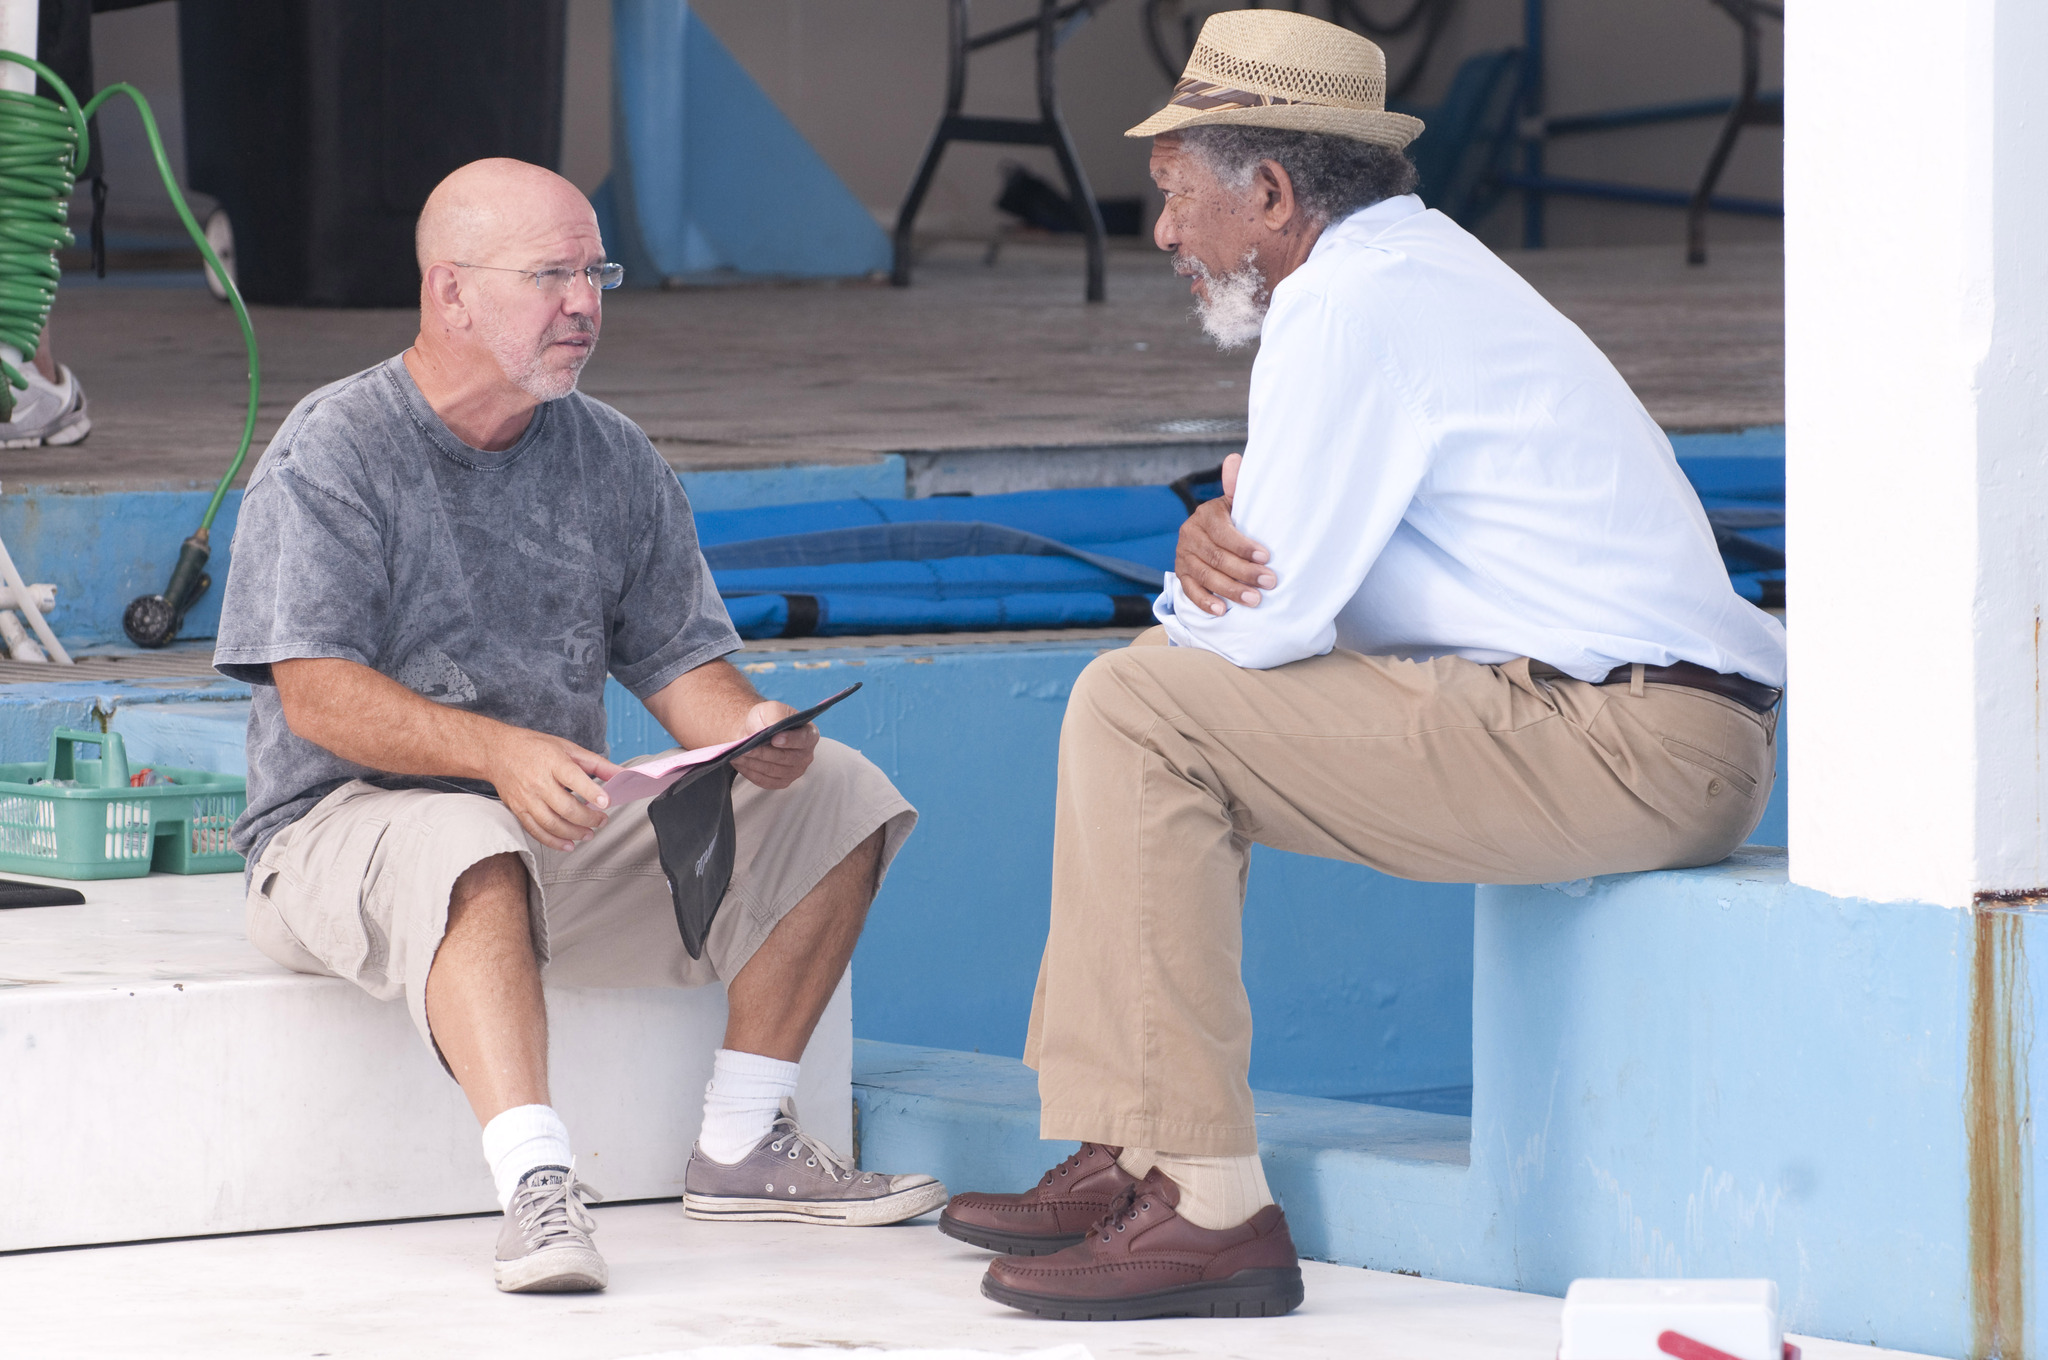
[{"xmin": 1153, "ymin": 195, "xmax": 1786, "ymax": 686}]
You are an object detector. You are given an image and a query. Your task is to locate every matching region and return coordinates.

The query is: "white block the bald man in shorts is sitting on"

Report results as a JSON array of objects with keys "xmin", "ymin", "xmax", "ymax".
[{"xmin": 0, "ymin": 875, "xmax": 852, "ymax": 1251}]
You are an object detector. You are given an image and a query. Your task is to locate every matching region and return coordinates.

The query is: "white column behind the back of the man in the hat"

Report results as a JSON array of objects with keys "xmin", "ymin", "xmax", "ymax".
[{"xmin": 1786, "ymin": 0, "xmax": 2048, "ymax": 907}]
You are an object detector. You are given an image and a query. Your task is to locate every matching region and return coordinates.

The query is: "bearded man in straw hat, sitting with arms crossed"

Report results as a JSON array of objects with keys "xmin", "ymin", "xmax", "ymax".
[{"xmin": 940, "ymin": 10, "xmax": 1784, "ymax": 1319}]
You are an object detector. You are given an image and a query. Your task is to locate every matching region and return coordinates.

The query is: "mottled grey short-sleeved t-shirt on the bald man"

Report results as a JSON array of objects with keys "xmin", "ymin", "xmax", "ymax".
[{"xmin": 213, "ymin": 358, "xmax": 739, "ymax": 862}]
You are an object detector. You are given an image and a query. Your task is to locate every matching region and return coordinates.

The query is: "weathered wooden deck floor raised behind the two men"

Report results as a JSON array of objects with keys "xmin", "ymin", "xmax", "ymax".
[{"xmin": 0, "ymin": 244, "xmax": 1784, "ymax": 490}]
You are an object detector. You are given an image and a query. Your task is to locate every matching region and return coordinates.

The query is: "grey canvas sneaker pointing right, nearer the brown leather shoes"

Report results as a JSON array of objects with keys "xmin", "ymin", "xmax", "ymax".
[{"xmin": 682, "ymin": 1100, "xmax": 946, "ymax": 1227}]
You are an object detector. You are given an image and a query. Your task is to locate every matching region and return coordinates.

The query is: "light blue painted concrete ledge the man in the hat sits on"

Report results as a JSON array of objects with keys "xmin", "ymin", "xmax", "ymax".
[{"xmin": 854, "ymin": 850, "xmax": 2048, "ymax": 1356}]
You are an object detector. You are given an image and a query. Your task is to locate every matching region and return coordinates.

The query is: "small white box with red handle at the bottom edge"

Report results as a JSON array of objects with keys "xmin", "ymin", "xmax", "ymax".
[{"xmin": 1556, "ymin": 1280, "xmax": 1798, "ymax": 1360}]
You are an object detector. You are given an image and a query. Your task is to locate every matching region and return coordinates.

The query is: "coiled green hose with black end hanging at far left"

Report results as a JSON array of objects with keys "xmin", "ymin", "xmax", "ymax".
[{"xmin": 0, "ymin": 51, "xmax": 262, "ymax": 647}]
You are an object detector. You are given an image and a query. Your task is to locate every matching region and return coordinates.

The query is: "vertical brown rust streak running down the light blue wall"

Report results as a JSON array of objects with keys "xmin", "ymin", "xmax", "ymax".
[{"xmin": 1964, "ymin": 893, "xmax": 2038, "ymax": 1360}]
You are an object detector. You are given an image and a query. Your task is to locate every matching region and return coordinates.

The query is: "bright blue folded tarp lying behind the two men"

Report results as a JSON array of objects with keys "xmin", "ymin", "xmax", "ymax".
[{"xmin": 696, "ymin": 457, "xmax": 1784, "ymax": 637}]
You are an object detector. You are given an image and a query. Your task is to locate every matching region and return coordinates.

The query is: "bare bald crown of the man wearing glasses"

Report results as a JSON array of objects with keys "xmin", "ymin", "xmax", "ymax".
[{"xmin": 412, "ymin": 158, "xmax": 598, "ymax": 277}]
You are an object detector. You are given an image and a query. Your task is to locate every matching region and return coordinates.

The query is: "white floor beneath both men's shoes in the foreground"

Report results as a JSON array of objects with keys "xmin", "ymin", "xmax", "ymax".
[{"xmin": 0, "ymin": 1204, "xmax": 1933, "ymax": 1360}]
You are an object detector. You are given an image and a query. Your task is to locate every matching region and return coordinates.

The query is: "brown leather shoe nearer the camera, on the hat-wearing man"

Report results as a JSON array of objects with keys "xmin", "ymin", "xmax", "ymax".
[{"xmin": 981, "ymin": 1170, "xmax": 1300, "ymax": 1321}]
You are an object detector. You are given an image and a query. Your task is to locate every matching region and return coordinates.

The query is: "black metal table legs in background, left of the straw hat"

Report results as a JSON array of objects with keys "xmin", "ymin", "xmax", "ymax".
[{"xmin": 889, "ymin": 0, "xmax": 1104, "ymax": 303}]
